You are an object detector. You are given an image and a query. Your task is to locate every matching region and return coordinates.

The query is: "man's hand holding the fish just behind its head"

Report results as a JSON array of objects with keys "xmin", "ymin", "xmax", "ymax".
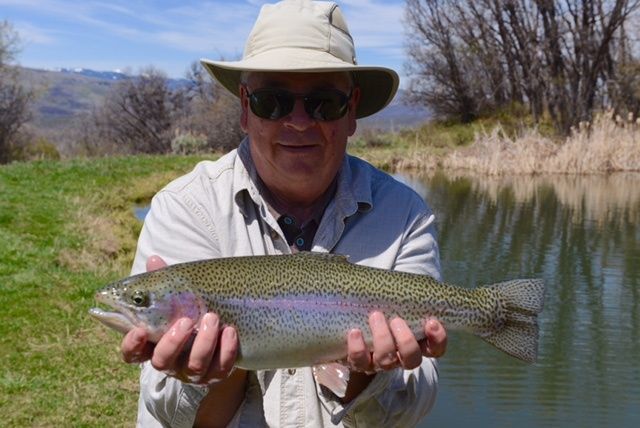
[{"xmin": 121, "ymin": 256, "xmax": 239, "ymax": 384}]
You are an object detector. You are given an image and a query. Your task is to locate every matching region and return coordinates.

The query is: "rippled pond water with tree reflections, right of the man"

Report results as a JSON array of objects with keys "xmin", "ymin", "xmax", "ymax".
[{"xmin": 399, "ymin": 174, "xmax": 640, "ymax": 427}]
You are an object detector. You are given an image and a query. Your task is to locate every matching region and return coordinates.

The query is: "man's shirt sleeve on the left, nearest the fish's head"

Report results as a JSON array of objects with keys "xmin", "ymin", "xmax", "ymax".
[{"xmin": 132, "ymin": 191, "xmax": 220, "ymax": 428}]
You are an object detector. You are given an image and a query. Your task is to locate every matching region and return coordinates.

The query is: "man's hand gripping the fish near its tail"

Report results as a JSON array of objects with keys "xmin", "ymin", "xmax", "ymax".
[{"xmin": 347, "ymin": 311, "xmax": 447, "ymax": 373}]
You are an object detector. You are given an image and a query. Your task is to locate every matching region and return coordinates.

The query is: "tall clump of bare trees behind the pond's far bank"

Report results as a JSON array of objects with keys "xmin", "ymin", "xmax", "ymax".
[{"xmin": 406, "ymin": 0, "xmax": 640, "ymax": 132}]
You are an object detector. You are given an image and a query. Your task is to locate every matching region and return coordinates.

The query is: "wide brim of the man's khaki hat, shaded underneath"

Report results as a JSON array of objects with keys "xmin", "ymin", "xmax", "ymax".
[{"xmin": 200, "ymin": 48, "xmax": 400, "ymax": 119}]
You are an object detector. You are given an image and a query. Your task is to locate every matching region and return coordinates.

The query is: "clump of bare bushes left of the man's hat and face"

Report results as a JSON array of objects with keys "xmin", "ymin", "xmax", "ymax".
[{"xmin": 90, "ymin": 63, "xmax": 243, "ymax": 155}]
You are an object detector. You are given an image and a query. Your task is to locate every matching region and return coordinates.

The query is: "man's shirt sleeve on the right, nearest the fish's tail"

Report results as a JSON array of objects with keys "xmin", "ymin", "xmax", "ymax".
[{"xmin": 318, "ymin": 208, "xmax": 442, "ymax": 427}]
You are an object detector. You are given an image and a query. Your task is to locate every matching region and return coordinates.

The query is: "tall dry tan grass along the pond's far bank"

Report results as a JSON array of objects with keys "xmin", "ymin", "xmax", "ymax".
[{"xmin": 442, "ymin": 112, "xmax": 640, "ymax": 175}]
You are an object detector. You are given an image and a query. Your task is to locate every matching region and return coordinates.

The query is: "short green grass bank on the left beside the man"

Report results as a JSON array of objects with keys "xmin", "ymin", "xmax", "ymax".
[{"xmin": 0, "ymin": 156, "xmax": 215, "ymax": 427}]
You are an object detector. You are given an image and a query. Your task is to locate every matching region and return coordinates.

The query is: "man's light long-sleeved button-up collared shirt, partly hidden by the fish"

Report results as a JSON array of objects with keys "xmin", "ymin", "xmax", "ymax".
[{"xmin": 132, "ymin": 139, "xmax": 440, "ymax": 427}]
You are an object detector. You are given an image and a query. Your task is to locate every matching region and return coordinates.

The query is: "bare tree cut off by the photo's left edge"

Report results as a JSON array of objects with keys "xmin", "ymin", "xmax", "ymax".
[{"xmin": 0, "ymin": 21, "xmax": 32, "ymax": 164}]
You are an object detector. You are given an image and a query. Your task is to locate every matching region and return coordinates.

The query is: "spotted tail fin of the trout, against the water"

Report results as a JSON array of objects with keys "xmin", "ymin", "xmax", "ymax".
[{"xmin": 481, "ymin": 279, "xmax": 544, "ymax": 363}]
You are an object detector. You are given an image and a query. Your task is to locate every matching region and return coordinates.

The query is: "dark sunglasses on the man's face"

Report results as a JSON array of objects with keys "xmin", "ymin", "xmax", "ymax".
[{"xmin": 248, "ymin": 88, "xmax": 352, "ymax": 122}]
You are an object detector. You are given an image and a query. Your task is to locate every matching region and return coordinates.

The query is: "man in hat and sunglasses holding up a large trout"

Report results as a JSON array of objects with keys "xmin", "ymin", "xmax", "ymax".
[{"xmin": 122, "ymin": 0, "xmax": 446, "ymax": 427}]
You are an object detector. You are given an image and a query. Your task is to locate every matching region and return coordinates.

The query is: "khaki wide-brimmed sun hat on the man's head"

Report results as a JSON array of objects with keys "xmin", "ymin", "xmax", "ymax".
[{"xmin": 201, "ymin": 0, "xmax": 399, "ymax": 118}]
